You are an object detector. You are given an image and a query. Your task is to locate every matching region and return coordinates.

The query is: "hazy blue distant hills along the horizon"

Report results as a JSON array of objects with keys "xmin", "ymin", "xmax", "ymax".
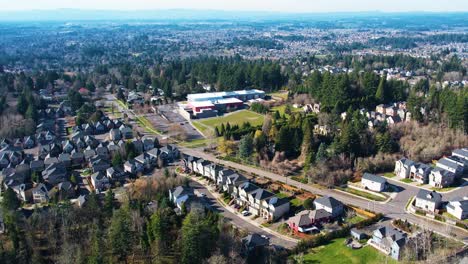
[{"xmin": 0, "ymin": 9, "xmax": 468, "ymax": 21}]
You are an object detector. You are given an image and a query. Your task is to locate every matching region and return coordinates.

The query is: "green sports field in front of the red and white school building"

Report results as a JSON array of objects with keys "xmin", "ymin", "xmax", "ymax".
[{"xmin": 192, "ymin": 110, "xmax": 264, "ymax": 134}]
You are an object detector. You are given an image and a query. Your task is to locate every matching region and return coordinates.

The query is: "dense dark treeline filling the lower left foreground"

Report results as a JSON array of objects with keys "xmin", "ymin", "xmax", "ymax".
[{"xmin": 0, "ymin": 173, "xmax": 260, "ymax": 264}]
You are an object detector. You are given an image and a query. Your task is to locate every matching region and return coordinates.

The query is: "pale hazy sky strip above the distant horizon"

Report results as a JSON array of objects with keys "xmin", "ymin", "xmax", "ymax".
[{"xmin": 0, "ymin": 0, "xmax": 468, "ymax": 13}]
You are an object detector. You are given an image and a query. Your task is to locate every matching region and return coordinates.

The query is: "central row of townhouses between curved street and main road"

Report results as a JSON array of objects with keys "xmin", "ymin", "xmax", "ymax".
[{"xmin": 184, "ymin": 156, "xmax": 290, "ymax": 221}]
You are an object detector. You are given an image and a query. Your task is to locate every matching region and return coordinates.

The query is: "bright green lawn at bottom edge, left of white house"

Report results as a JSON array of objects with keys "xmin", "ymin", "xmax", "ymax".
[{"xmin": 304, "ymin": 238, "xmax": 398, "ymax": 264}]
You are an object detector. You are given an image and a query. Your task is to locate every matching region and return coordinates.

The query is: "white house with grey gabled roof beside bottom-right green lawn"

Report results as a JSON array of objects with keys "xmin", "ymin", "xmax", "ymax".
[{"xmin": 371, "ymin": 226, "xmax": 407, "ymax": 260}]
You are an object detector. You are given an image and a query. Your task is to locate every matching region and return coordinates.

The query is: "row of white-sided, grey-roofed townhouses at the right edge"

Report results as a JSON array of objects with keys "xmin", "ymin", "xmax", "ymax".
[{"xmin": 394, "ymin": 148, "xmax": 468, "ymax": 188}]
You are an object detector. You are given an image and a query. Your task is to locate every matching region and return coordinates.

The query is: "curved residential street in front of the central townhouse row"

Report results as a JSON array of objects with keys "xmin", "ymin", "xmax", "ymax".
[{"xmin": 190, "ymin": 181, "xmax": 297, "ymax": 248}]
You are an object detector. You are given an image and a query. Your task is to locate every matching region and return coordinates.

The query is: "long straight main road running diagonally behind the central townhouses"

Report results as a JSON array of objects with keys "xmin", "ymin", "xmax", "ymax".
[{"xmin": 180, "ymin": 147, "xmax": 468, "ymax": 243}]
